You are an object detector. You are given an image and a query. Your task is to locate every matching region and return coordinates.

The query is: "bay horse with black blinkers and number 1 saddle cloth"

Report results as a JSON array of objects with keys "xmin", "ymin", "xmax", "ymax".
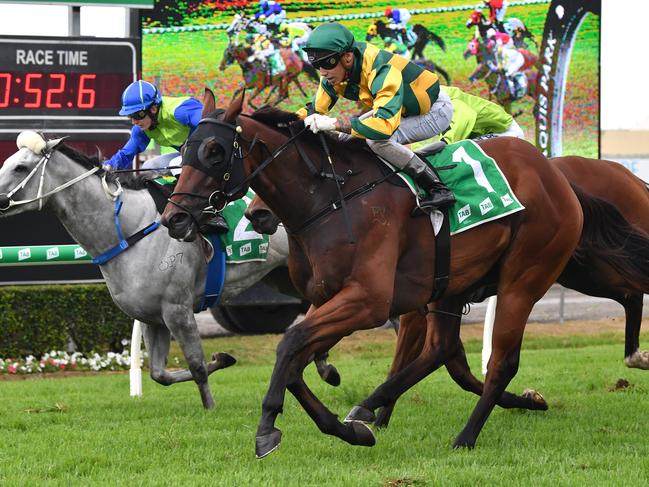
[{"xmin": 162, "ymin": 90, "xmax": 588, "ymax": 457}]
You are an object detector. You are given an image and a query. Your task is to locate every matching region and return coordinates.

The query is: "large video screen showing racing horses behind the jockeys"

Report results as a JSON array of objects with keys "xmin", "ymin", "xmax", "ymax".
[{"xmin": 142, "ymin": 0, "xmax": 600, "ymax": 157}]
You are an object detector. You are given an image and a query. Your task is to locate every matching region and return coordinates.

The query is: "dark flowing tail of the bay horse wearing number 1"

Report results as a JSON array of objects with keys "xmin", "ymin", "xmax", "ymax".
[{"xmin": 572, "ymin": 185, "xmax": 649, "ymax": 292}]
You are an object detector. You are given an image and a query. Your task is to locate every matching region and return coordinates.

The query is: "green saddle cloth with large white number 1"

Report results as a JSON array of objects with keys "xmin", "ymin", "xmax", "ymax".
[{"xmin": 399, "ymin": 140, "xmax": 525, "ymax": 235}]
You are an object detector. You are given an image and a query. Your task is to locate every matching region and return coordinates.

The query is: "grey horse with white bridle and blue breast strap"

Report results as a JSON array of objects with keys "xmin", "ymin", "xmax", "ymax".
[{"xmin": 0, "ymin": 131, "xmax": 339, "ymax": 409}]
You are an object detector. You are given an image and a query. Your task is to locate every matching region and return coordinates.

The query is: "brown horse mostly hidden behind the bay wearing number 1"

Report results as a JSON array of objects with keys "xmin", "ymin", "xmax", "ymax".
[{"xmin": 246, "ymin": 156, "xmax": 649, "ymax": 426}]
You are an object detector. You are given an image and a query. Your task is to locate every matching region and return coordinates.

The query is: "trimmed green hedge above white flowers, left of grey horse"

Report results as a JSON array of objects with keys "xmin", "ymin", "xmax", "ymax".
[{"xmin": 0, "ymin": 284, "xmax": 133, "ymax": 357}]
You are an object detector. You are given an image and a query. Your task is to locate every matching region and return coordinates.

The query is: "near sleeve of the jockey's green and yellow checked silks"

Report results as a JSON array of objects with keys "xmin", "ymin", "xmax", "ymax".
[{"xmin": 351, "ymin": 64, "xmax": 403, "ymax": 140}]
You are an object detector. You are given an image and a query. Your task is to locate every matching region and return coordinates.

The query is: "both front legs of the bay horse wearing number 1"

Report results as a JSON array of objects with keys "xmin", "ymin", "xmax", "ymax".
[{"xmin": 256, "ymin": 284, "xmax": 390, "ymax": 458}]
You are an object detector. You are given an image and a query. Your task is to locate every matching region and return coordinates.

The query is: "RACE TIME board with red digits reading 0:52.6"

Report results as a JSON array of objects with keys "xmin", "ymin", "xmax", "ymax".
[{"xmin": 0, "ymin": 37, "xmax": 138, "ymax": 121}]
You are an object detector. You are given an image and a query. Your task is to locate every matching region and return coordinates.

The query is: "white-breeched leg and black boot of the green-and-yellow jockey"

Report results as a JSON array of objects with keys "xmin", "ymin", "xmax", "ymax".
[{"xmin": 367, "ymin": 91, "xmax": 455, "ymax": 210}]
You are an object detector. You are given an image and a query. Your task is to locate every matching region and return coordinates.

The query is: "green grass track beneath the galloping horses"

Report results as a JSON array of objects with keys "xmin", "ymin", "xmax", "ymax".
[{"xmin": 0, "ymin": 321, "xmax": 649, "ymax": 486}]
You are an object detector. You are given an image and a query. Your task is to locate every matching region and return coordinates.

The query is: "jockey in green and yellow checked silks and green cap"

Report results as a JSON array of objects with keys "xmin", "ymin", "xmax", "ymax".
[{"xmin": 298, "ymin": 22, "xmax": 455, "ymax": 210}]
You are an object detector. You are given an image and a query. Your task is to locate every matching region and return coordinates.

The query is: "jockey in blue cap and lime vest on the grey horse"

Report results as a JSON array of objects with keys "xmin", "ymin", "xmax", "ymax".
[{"xmin": 103, "ymin": 80, "xmax": 228, "ymax": 232}]
